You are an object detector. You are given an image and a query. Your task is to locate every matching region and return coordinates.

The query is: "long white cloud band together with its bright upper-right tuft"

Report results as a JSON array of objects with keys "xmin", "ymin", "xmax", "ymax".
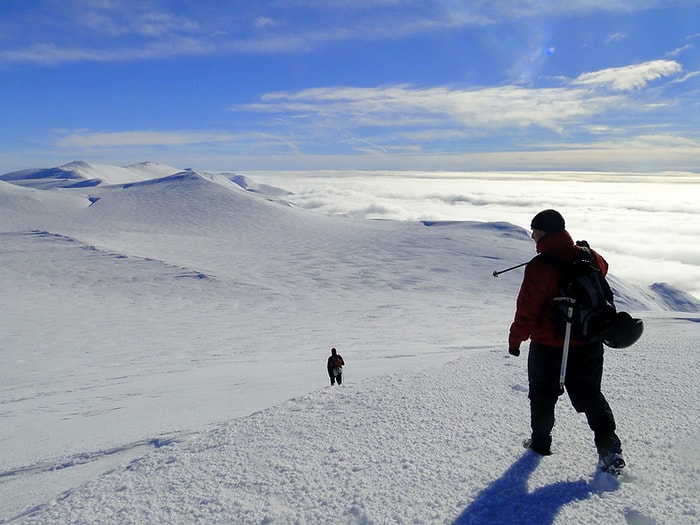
[{"xmin": 232, "ymin": 60, "xmax": 682, "ymax": 133}]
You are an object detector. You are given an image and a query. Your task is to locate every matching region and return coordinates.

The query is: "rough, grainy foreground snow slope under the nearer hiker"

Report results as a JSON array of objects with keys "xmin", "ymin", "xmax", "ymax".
[{"xmin": 10, "ymin": 321, "xmax": 700, "ymax": 525}]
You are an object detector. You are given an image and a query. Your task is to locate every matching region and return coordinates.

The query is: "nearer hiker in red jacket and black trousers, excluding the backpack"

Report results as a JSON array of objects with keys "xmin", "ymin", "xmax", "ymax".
[{"xmin": 508, "ymin": 210, "xmax": 625, "ymax": 470}]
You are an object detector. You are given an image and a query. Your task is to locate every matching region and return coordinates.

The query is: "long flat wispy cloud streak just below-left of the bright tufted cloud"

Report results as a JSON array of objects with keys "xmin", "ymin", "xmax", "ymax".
[{"xmin": 233, "ymin": 86, "xmax": 600, "ymax": 130}]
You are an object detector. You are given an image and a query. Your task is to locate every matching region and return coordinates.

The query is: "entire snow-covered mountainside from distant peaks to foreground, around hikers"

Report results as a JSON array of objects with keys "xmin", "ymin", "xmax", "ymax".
[{"xmin": 0, "ymin": 162, "xmax": 700, "ymax": 523}]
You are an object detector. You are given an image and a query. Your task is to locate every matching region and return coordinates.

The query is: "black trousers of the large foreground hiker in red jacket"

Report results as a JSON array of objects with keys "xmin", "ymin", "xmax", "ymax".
[{"xmin": 527, "ymin": 342, "xmax": 622, "ymax": 454}]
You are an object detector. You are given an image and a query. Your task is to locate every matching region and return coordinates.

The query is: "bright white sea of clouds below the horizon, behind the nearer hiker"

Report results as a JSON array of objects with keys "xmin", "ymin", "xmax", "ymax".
[{"xmin": 246, "ymin": 171, "xmax": 700, "ymax": 298}]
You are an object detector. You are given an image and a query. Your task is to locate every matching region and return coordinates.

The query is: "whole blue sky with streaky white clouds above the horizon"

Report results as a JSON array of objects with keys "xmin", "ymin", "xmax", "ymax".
[{"xmin": 0, "ymin": 0, "xmax": 700, "ymax": 173}]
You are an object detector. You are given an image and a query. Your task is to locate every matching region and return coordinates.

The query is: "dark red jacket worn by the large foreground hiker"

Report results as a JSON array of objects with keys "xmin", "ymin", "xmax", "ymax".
[{"xmin": 508, "ymin": 231, "xmax": 608, "ymax": 349}]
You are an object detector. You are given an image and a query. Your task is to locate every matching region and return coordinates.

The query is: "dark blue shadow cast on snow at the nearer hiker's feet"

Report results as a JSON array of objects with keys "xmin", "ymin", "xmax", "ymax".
[{"xmin": 453, "ymin": 451, "xmax": 591, "ymax": 525}]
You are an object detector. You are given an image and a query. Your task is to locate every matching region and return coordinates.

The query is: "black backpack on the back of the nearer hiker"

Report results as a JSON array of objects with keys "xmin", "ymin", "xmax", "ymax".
[{"xmin": 537, "ymin": 241, "xmax": 616, "ymax": 343}]
